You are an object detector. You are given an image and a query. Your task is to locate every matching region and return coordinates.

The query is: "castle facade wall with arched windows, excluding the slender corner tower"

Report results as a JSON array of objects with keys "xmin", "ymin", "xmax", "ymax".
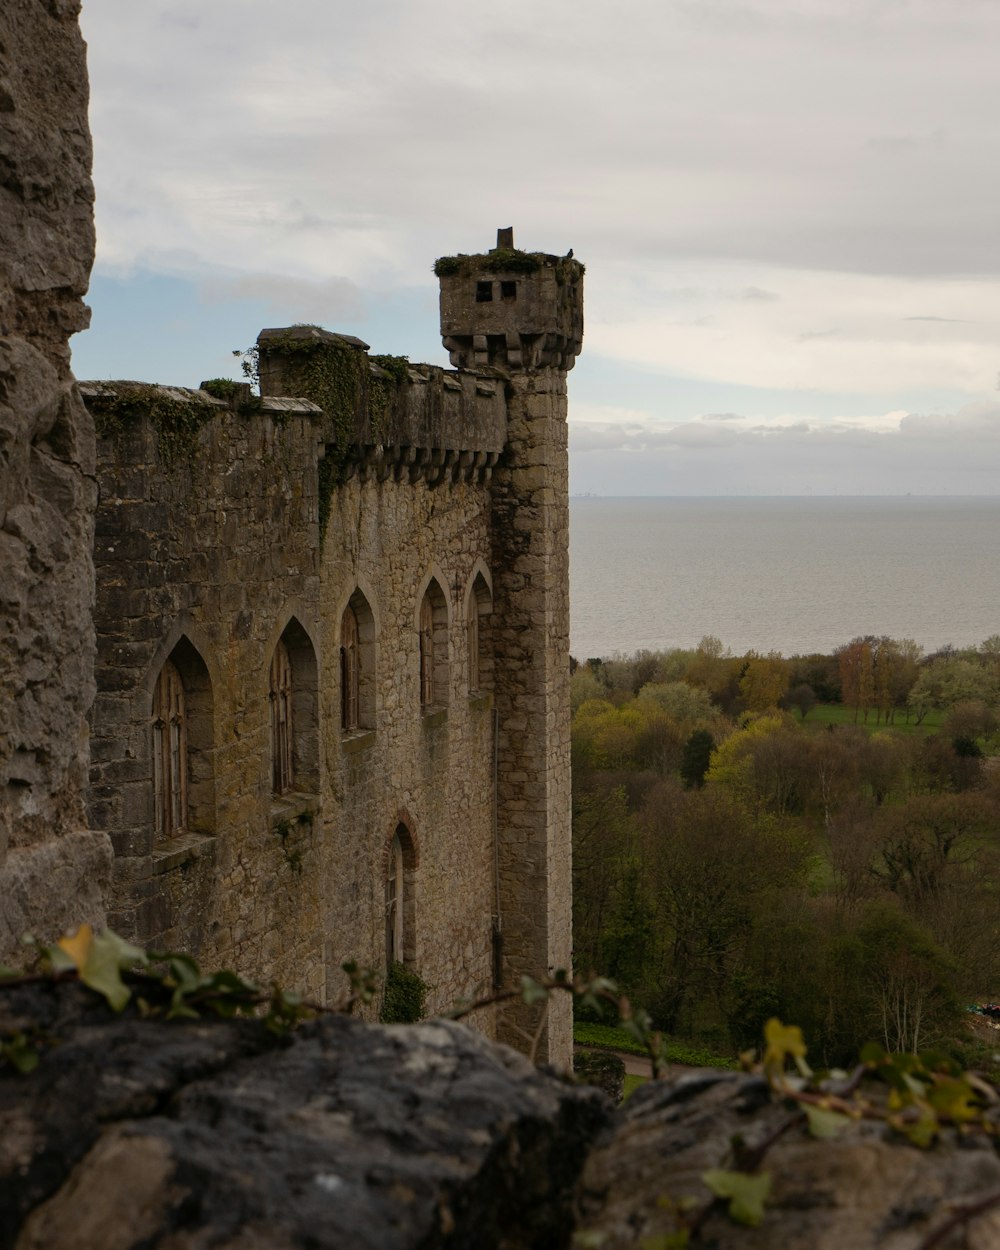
[{"xmin": 84, "ymin": 360, "xmax": 505, "ymax": 1029}]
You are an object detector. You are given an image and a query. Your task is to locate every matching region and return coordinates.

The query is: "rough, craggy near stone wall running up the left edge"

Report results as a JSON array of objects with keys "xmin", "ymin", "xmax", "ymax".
[{"xmin": 0, "ymin": 0, "xmax": 110, "ymax": 961}]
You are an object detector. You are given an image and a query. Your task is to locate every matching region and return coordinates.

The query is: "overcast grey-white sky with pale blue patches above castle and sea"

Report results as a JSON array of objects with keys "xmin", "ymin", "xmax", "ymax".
[{"xmin": 74, "ymin": 0, "xmax": 1000, "ymax": 495}]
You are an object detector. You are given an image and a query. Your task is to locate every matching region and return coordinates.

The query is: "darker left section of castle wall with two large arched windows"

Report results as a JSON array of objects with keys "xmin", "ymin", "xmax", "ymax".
[{"xmin": 83, "ymin": 384, "xmax": 325, "ymax": 993}]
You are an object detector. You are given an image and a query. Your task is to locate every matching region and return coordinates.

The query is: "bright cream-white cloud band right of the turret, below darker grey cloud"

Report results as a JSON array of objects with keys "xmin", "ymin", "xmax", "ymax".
[{"xmin": 586, "ymin": 261, "xmax": 1000, "ymax": 394}]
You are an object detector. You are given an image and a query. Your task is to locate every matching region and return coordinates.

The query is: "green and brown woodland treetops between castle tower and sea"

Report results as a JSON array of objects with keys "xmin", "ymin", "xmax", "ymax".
[{"xmin": 571, "ymin": 635, "xmax": 1000, "ymax": 1064}]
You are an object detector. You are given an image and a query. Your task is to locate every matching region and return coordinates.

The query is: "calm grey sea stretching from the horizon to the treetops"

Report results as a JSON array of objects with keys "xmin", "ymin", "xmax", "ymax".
[{"xmin": 570, "ymin": 496, "xmax": 1000, "ymax": 659}]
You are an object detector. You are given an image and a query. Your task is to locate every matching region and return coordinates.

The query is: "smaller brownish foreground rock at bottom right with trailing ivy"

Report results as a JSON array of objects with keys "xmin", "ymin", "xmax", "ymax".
[{"xmin": 578, "ymin": 1070, "xmax": 1000, "ymax": 1250}]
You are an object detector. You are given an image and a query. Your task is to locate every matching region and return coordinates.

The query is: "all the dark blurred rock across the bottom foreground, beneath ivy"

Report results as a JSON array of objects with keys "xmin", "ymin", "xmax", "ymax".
[{"xmin": 0, "ymin": 984, "xmax": 1000, "ymax": 1250}]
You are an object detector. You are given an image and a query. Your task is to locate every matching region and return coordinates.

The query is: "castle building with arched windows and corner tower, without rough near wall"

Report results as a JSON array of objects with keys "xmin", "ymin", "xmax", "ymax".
[{"xmin": 83, "ymin": 238, "xmax": 583, "ymax": 1063}]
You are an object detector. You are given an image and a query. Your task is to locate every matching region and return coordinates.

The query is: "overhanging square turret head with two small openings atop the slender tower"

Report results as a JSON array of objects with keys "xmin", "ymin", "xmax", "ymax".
[{"xmin": 434, "ymin": 228, "xmax": 584, "ymax": 373}]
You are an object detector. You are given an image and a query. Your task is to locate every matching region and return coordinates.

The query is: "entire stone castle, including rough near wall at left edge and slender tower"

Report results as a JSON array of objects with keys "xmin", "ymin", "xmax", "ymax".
[{"xmin": 0, "ymin": 4, "xmax": 583, "ymax": 1060}]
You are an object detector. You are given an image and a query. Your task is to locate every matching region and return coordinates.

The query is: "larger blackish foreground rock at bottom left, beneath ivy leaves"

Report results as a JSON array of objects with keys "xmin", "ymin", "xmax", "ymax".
[{"xmin": 0, "ymin": 988, "xmax": 610, "ymax": 1250}]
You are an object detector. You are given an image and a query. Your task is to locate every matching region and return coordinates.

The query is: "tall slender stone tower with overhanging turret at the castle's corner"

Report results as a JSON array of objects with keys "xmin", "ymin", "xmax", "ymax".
[{"xmin": 435, "ymin": 230, "xmax": 584, "ymax": 1065}]
